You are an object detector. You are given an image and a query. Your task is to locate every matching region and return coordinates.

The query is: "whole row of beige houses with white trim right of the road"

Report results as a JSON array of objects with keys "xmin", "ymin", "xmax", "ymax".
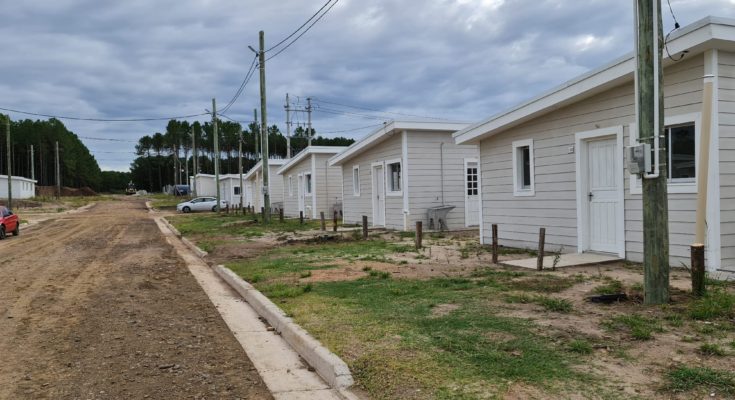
[{"xmin": 191, "ymin": 17, "xmax": 735, "ymax": 271}]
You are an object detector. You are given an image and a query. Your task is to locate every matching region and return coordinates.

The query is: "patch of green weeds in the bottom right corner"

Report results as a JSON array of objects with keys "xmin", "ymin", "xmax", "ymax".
[{"xmin": 666, "ymin": 366, "xmax": 735, "ymax": 396}]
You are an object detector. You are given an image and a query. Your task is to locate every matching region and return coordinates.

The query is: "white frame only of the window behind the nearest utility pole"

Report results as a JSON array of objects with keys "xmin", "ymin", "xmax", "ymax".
[{"xmin": 626, "ymin": 113, "xmax": 702, "ymax": 194}]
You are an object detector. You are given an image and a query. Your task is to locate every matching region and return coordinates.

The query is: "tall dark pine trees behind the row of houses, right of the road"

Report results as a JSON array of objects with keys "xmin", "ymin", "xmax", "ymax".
[{"xmin": 130, "ymin": 120, "xmax": 354, "ymax": 192}]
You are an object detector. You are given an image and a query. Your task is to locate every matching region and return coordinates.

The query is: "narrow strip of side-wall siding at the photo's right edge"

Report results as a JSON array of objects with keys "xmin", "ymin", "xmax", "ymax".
[{"xmin": 717, "ymin": 51, "xmax": 735, "ymax": 271}]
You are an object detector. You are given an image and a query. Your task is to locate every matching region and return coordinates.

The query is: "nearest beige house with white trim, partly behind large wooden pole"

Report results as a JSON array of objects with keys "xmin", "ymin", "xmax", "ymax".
[{"xmin": 454, "ymin": 17, "xmax": 735, "ymax": 270}]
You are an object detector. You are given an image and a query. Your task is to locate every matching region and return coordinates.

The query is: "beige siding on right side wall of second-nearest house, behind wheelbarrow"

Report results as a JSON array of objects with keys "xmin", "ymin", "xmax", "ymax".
[{"xmin": 408, "ymin": 132, "xmax": 478, "ymax": 230}]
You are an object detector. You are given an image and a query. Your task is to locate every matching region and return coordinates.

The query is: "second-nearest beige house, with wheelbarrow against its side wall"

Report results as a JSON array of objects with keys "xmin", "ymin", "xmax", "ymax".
[{"xmin": 329, "ymin": 121, "xmax": 479, "ymax": 230}]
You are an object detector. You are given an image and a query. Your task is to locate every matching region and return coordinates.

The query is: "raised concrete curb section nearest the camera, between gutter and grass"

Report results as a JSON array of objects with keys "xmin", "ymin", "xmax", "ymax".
[{"xmin": 213, "ymin": 265, "xmax": 354, "ymax": 389}]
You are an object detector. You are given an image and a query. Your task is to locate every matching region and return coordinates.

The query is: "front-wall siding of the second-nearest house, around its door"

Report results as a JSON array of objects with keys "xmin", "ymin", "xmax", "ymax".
[{"xmin": 342, "ymin": 134, "xmax": 403, "ymax": 229}]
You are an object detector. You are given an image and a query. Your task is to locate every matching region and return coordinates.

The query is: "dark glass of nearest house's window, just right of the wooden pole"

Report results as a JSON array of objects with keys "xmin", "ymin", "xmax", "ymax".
[{"xmin": 664, "ymin": 123, "xmax": 696, "ymax": 182}]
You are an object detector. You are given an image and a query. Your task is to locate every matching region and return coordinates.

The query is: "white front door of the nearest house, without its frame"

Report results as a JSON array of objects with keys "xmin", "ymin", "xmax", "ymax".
[{"xmin": 586, "ymin": 138, "xmax": 622, "ymax": 253}]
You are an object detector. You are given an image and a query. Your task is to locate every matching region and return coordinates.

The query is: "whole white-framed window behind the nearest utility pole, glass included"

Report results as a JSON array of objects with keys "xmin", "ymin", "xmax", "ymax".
[{"xmin": 629, "ymin": 113, "xmax": 701, "ymax": 194}]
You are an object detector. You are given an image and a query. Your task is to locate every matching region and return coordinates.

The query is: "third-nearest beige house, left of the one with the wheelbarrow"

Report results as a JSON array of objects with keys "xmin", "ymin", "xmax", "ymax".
[{"xmin": 278, "ymin": 146, "xmax": 347, "ymax": 218}]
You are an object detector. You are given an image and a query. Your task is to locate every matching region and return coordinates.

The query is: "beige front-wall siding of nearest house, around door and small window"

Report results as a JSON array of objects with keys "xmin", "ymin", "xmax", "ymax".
[{"xmin": 480, "ymin": 56, "xmax": 704, "ymax": 265}]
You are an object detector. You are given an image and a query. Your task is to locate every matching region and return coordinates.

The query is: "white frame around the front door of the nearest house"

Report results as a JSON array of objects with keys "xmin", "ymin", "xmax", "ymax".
[{"xmin": 573, "ymin": 125, "xmax": 625, "ymax": 258}]
